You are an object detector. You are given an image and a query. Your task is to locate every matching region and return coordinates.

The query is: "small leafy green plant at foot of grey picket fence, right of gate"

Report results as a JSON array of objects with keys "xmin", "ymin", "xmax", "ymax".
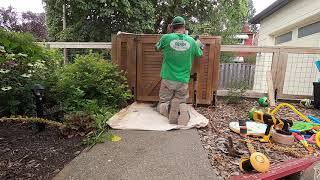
[{"xmin": 224, "ymin": 81, "xmax": 248, "ymax": 104}]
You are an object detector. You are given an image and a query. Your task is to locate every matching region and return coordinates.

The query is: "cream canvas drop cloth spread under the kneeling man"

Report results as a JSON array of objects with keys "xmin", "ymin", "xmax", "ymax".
[{"xmin": 107, "ymin": 102, "xmax": 209, "ymax": 131}]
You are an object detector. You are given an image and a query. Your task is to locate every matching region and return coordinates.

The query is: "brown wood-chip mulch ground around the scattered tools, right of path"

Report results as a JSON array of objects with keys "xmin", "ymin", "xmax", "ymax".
[{"xmin": 197, "ymin": 100, "xmax": 320, "ymax": 179}]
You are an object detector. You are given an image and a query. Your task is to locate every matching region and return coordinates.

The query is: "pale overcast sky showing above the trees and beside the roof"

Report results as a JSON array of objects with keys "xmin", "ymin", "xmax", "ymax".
[{"xmin": 0, "ymin": 0, "xmax": 276, "ymax": 13}]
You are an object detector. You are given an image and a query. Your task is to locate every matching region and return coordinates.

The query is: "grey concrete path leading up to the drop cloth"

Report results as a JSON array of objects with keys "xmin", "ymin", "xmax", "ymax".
[{"xmin": 54, "ymin": 129, "xmax": 216, "ymax": 180}]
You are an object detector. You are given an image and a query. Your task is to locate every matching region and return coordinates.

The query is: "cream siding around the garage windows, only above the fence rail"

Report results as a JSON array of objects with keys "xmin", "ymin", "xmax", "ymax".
[{"xmin": 258, "ymin": 0, "xmax": 320, "ymax": 47}]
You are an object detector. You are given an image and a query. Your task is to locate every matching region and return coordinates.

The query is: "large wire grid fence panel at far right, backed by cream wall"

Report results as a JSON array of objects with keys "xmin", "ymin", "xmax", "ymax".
[{"xmin": 283, "ymin": 53, "xmax": 320, "ymax": 96}]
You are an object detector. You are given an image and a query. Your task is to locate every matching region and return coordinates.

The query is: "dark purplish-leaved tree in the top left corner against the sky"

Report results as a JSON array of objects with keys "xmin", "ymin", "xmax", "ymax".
[{"xmin": 0, "ymin": 6, "xmax": 48, "ymax": 40}]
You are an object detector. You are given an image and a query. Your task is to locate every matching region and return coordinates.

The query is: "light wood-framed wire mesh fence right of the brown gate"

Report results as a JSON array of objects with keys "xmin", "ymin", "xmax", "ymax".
[{"xmin": 218, "ymin": 45, "xmax": 320, "ymax": 99}]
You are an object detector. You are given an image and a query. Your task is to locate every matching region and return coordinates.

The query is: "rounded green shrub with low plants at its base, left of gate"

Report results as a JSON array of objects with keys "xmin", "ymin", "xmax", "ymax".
[{"xmin": 54, "ymin": 53, "xmax": 131, "ymax": 147}]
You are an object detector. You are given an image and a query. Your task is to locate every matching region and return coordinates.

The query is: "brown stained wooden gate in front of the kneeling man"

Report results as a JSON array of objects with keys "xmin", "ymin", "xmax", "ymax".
[{"xmin": 112, "ymin": 35, "xmax": 220, "ymax": 104}]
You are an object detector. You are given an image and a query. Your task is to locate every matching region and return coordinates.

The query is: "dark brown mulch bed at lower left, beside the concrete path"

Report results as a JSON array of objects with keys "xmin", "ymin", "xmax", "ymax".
[{"xmin": 0, "ymin": 122, "xmax": 85, "ymax": 179}]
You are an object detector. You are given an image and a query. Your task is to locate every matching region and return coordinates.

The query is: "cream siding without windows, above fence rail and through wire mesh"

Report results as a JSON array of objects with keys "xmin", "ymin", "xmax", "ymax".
[{"xmin": 254, "ymin": 0, "xmax": 320, "ymax": 95}]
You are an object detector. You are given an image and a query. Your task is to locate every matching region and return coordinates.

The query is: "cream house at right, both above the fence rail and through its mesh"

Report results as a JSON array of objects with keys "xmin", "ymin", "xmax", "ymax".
[{"xmin": 250, "ymin": 0, "xmax": 320, "ymax": 96}]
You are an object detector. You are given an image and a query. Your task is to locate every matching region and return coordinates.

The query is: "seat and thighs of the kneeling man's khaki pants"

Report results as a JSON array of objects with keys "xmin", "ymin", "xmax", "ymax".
[{"xmin": 159, "ymin": 79, "xmax": 189, "ymax": 103}]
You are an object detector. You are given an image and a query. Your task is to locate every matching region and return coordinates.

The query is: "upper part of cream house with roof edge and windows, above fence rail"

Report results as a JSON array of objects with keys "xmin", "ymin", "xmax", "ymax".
[{"xmin": 250, "ymin": 0, "xmax": 320, "ymax": 47}]
